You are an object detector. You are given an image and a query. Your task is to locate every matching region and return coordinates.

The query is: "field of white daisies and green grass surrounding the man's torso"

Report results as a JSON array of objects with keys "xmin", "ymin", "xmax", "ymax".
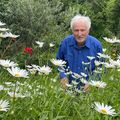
[{"xmin": 0, "ymin": 22, "xmax": 120, "ymax": 120}]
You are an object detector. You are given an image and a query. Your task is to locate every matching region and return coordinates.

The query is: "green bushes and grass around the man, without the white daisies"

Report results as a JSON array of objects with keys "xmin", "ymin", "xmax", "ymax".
[{"xmin": 0, "ymin": 0, "xmax": 120, "ymax": 120}]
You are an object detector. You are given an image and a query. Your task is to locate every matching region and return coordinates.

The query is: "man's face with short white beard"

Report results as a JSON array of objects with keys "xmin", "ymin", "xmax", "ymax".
[{"xmin": 73, "ymin": 20, "xmax": 89, "ymax": 45}]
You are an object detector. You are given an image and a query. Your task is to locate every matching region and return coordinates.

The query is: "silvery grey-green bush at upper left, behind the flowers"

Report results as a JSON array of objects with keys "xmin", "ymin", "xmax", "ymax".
[{"xmin": 1, "ymin": 0, "xmax": 64, "ymax": 45}]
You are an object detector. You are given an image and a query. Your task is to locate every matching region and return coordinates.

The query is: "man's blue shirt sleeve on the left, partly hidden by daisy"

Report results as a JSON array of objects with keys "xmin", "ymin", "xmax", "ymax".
[{"xmin": 56, "ymin": 41, "xmax": 66, "ymax": 79}]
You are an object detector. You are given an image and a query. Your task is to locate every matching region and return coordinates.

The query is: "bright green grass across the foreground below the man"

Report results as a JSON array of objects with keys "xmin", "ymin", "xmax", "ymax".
[{"xmin": 0, "ymin": 65, "xmax": 120, "ymax": 120}]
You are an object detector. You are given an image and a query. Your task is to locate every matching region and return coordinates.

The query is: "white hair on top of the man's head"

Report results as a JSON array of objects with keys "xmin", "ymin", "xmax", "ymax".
[{"xmin": 70, "ymin": 14, "xmax": 91, "ymax": 30}]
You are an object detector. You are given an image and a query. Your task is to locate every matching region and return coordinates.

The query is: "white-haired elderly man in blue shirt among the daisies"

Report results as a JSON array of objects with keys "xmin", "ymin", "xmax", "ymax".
[{"xmin": 57, "ymin": 15, "xmax": 102, "ymax": 90}]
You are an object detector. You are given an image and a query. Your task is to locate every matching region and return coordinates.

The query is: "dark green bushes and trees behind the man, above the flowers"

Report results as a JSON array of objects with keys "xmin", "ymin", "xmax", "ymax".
[{"xmin": 0, "ymin": 0, "xmax": 120, "ymax": 60}]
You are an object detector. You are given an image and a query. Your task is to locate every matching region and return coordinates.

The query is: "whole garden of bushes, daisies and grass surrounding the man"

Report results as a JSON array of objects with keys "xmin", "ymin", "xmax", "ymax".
[{"xmin": 0, "ymin": 0, "xmax": 120, "ymax": 120}]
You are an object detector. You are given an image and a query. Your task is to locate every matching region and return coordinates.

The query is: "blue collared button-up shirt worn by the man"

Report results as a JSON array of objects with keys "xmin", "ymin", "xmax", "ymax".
[{"xmin": 57, "ymin": 35, "xmax": 102, "ymax": 80}]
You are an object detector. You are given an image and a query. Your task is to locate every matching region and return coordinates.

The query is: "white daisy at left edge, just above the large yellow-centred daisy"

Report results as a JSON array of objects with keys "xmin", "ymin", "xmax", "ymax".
[{"xmin": 0, "ymin": 60, "xmax": 18, "ymax": 68}]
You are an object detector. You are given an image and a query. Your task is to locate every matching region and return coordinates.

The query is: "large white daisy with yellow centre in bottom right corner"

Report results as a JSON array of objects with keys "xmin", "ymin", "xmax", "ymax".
[{"xmin": 94, "ymin": 102, "xmax": 116, "ymax": 116}]
